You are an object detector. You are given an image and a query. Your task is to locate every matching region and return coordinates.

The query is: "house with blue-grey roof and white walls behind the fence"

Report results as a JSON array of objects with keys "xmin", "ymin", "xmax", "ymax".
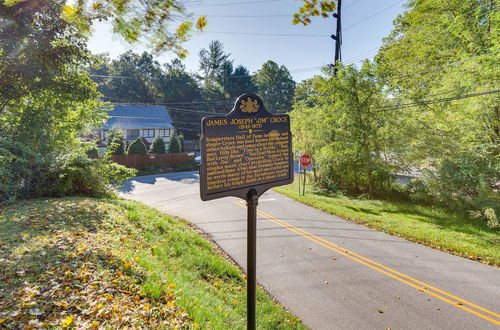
[{"xmin": 97, "ymin": 105, "xmax": 174, "ymax": 147}]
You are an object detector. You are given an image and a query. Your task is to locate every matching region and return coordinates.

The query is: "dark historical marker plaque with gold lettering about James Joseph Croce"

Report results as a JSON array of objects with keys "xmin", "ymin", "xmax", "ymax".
[{"xmin": 200, "ymin": 94, "xmax": 293, "ymax": 200}]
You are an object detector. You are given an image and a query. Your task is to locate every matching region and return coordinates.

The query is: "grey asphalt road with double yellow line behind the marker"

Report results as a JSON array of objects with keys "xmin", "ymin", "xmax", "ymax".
[{"xmin": 123, "ymin": 172, "xmax": 500, "ymax": 330}]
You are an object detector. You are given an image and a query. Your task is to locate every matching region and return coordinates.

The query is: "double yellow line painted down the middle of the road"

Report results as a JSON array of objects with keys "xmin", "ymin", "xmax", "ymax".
[{"xmin": 234, "ymin": 201, "xmax": 500, "ymax": 325}]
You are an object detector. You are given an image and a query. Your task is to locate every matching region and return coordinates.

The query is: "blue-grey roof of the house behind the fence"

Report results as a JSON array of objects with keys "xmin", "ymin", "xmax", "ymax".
[{"xmin": 102, "ymin": 105, "xmax": 174, "ymax": 129}]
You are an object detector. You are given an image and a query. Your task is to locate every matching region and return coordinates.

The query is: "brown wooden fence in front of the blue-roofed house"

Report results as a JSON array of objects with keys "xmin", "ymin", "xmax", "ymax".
[{"xmin": 111, "ymin": 152, "xmax": 194, "ymax": 168}]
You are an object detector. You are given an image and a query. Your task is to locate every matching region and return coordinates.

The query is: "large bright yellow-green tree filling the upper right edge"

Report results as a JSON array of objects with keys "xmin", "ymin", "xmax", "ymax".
[{"xmin": 376, "ymin": 0, "xmax": 500, "ymax": 206}]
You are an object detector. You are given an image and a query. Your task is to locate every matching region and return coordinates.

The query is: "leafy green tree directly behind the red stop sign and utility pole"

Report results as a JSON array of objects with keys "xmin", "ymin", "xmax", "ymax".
[{"xmin": 291, "ymin": 62, "xmax": 390, "ymax": 196}]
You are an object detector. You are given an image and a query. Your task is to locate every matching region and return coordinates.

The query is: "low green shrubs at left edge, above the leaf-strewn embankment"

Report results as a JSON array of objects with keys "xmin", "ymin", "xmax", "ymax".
[{"xmin": 0, "ymin": 138, "xmax": 136, "ymax": 203}]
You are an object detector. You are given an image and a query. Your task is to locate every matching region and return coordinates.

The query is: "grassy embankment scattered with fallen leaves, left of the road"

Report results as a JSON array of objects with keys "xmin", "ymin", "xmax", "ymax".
[{"xmin": 0, "ymin": 198, "xmax": 305, "ymax": 329}]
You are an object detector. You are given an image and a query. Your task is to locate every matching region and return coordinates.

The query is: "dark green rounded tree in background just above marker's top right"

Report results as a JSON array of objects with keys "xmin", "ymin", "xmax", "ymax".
[{"xmin": 254, "ymin": 61, "xmax": 295, "ymax": 113}]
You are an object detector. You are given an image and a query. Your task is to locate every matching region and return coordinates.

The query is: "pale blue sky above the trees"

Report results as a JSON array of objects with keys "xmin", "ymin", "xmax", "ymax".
[{"xmin": 89, "ymin": 0, "xmax": 407, "ymax": 82}]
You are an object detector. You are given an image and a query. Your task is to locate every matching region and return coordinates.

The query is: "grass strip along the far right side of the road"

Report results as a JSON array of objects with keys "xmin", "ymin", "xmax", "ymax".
[{"xmin": 275, "ymin": 180, "xmax": 500, "ymax": 266}]
